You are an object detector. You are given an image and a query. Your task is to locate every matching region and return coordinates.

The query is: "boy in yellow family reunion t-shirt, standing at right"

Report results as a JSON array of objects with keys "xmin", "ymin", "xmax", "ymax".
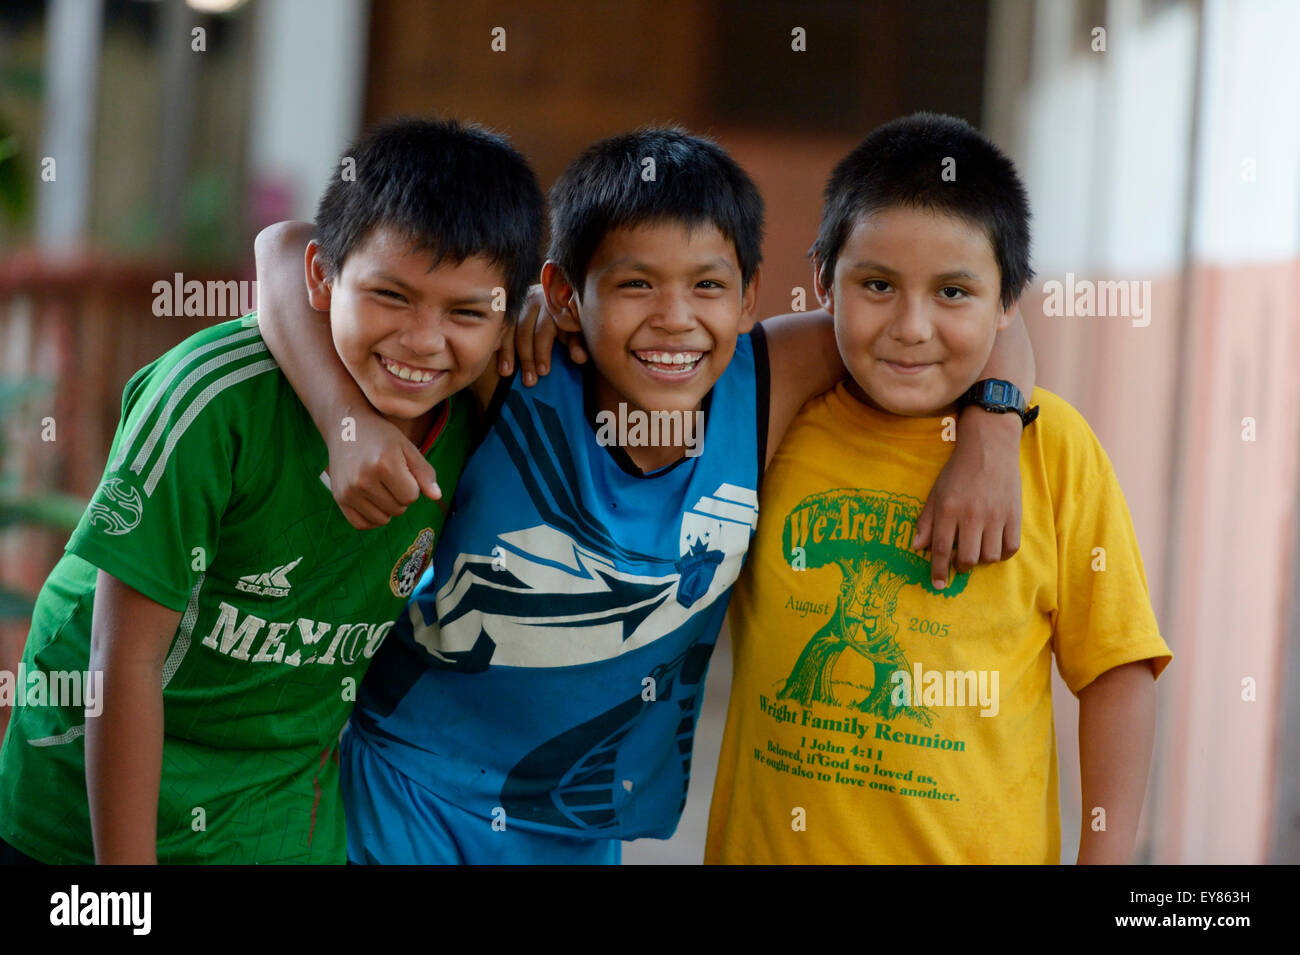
[{"xmin": 706, "ymin": 114, "xmax": 1171, "ymax": 863}]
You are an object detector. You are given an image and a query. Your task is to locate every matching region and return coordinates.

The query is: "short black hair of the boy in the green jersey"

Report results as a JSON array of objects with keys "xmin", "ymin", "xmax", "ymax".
[{"xmin": 316, "ymin": 117, "xmax": 543, "ymax": 321}]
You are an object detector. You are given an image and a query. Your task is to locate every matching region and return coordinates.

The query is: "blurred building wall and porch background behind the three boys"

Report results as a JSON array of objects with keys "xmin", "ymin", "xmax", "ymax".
[{"xmin": 0, "ymin": 0, "xmax": 1300, "ymax": 863}]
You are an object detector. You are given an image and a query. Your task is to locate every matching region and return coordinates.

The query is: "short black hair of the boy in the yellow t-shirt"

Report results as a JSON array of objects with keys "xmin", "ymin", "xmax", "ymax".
[{"xmin": 809, "ymin": 113, "xmax": 1034, "ymax": 308}]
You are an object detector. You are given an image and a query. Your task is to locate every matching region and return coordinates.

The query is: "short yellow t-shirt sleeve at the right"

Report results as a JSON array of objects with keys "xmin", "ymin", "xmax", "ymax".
[{"xmin": 1053, "ymin": 426, "xmax": 1173, "ymax": 695}]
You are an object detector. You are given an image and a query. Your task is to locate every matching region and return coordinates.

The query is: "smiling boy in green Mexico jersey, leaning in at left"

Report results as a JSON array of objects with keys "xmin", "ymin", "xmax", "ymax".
[{"xmin": 0, "ymin": 120, "xmax": 542, "ymax": 863}]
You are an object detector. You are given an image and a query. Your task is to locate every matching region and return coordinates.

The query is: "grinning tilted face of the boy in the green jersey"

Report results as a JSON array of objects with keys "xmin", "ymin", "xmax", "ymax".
[{"xmin": 307, "ymin": 226, "xmax": 506, "ymax": 442}]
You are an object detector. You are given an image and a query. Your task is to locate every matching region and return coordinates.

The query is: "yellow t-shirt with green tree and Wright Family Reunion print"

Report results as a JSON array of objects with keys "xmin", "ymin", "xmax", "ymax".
[{"xmin": 705, "ymin": 383, "xmax": 1173, "ymax": 863}]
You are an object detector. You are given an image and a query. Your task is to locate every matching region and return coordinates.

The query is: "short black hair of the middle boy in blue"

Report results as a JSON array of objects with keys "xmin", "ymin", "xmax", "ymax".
[{"xmin": 547, "ymin": 126, "xmax": 763, "ymax": 290}]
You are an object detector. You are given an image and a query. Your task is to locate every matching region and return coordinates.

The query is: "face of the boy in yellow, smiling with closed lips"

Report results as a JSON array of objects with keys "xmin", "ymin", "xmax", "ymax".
[{"xmin": 814, "ymin": 207, "xmax": 1014, "ymax": 417}]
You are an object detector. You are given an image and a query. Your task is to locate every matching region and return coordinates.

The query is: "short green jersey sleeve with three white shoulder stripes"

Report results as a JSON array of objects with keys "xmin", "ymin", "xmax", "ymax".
[{"xmin": 66, "ymin": 330, "xmax": 276, "ymax": 611}]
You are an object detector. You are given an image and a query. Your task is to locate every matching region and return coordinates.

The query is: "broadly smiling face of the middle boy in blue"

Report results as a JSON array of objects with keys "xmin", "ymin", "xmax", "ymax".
[{"xmin": 546, "ymin": 221, "xmax": 758, "ymax": 423}]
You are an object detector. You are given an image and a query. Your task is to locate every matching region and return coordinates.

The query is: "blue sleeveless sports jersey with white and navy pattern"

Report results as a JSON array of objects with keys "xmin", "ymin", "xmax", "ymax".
[{"xmin": 351, "ymin": 329, "xmax": 768, "ymax": 839}]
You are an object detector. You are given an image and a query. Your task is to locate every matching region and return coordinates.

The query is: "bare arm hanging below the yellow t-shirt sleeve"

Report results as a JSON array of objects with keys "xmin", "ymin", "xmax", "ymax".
[{"xmin": 1079, "ymin": 660, "xmax": 1156, "ymax": 865}]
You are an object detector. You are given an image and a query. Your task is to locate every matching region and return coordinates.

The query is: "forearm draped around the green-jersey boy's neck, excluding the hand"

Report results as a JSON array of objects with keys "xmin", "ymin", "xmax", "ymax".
[{"xmin": 254, "ymin": 222, "xmax": 374, "ymax": 438}]
